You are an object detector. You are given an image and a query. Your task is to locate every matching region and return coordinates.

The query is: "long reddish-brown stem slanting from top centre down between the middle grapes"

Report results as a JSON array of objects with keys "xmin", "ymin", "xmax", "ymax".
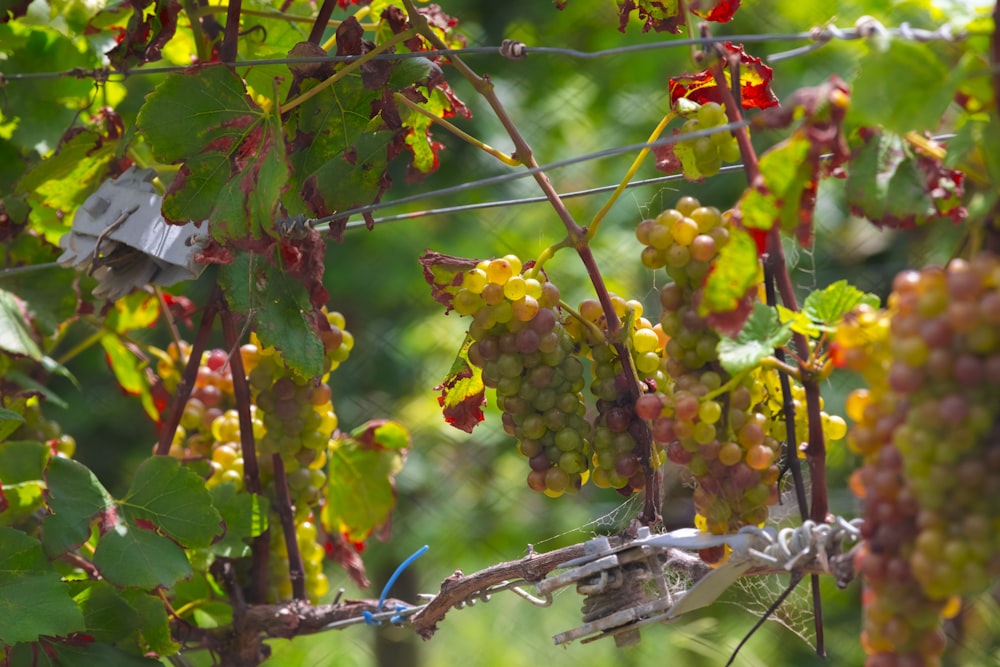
[{"xmin": 403, "ymin": 0, "xmax": 660, "ymax": 525}]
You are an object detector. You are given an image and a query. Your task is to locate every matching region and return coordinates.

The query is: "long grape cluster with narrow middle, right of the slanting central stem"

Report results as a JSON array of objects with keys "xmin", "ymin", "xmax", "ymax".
[{"xmin": 636, "ymin": 197, "xmax": 781, "ymax": 560}]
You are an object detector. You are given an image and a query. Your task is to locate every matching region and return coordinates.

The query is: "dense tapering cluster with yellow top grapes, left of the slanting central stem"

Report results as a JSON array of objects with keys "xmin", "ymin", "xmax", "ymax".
[{"xmin": 453, "ymin": 255, "xmax": 590, "ymax": 497}]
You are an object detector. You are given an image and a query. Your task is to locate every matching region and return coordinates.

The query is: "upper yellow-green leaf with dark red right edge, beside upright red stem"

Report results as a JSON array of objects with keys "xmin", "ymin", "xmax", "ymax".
[{"xmin": 737, "ymin": 132, "xmax": 816, "ymax": 241}]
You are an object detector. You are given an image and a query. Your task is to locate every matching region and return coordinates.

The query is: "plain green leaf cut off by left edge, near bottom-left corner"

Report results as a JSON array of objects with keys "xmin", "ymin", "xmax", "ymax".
[{"xmin": 0, "ymin": 527, "xmax": 84, "ymax": 644}]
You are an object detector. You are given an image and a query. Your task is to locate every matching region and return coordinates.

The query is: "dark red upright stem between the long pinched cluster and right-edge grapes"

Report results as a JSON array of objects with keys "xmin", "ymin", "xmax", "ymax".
[{"xmin": 711, "ymin": 48, "xmax": 828, "ymax": 656}]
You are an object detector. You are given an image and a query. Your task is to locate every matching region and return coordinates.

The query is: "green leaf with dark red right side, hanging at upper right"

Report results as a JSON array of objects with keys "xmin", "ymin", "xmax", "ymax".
[{"xmin": 847, "ymin": 128, "xmax": 966, "ymax": 229}]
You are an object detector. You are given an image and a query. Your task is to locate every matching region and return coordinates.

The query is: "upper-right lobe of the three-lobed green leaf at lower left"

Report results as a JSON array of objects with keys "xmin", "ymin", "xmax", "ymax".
[{"xmin": 119, "ymin": 456, "xmax": 223, "ymax": 547}]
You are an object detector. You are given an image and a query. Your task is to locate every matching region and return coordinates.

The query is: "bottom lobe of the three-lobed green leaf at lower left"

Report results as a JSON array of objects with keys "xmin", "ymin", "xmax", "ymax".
[{"xmin": 94, "ymin": 520, "xmax": 191, "ymax": 590}]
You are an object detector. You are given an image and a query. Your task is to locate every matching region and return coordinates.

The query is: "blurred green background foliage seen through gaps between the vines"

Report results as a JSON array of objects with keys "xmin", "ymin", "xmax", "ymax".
[{"xmin": 29, "ymin": 0, "xmax": 1000, "ymax": 667}]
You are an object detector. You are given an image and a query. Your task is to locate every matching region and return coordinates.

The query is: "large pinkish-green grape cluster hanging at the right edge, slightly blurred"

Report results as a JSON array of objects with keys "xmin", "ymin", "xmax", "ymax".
[{"xmin": 835, "ymin": 255, "xmax": 1000, "ymax": 666}]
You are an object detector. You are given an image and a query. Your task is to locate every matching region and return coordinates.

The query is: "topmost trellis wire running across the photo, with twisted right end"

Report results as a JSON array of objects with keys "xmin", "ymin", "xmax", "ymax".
[{"xmin": 0, "ymin": 16, "xmax": 969, "ymax": 85}]
